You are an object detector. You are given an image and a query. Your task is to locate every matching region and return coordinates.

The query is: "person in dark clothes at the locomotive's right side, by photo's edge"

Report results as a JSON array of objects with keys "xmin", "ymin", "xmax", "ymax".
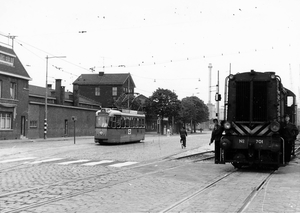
[{"xmin": 280, "ymin": 114, "xmax": 299, "ymax": 162}]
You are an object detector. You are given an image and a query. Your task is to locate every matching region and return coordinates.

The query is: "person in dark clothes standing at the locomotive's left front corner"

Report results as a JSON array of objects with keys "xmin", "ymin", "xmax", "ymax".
[{"xmin": 209, "ymin": 118, "xmax": 224, "ymax": 163}]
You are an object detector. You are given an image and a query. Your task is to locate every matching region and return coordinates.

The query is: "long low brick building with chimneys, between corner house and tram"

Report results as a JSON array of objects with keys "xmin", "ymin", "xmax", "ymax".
[{"xmin": 28, "ymin": 79, "xmax": 100, "ymax": 138}]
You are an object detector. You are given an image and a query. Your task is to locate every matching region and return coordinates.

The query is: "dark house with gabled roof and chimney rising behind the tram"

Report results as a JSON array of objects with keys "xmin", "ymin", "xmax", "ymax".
[{"xmin": 73, "ymin": 72, "xmax": 135, "ymax": 107}]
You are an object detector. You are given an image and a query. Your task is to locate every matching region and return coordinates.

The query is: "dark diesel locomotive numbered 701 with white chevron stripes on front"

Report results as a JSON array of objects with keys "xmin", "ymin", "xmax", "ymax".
[{"xmin": 215, "ymin": 70, "xmax": 297, "ymax": 168}]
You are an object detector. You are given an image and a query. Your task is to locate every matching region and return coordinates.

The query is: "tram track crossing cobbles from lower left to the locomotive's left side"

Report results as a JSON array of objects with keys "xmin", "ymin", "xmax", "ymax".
[{"xmin": 0, "ymin": 149, "xmax": 213, "ymax": 213}]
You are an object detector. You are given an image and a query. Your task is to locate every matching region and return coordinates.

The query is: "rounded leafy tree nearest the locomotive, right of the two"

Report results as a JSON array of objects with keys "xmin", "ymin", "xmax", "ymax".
[{"xmin": 180, "ymin": 96, "xmax": 209, "ymax": 132}]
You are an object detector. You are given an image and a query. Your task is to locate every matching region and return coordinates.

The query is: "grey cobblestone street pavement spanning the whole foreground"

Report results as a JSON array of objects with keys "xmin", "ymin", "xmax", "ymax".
[{"xmin": 0, "ymin": 134, "xmax": 300, "ymax": 213}]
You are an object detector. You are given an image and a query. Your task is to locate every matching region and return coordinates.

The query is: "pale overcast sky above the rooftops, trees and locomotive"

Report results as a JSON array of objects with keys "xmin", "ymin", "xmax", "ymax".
[{"xmin": 0, "ymin": 0, "xmax": 300, "ymax": 103}]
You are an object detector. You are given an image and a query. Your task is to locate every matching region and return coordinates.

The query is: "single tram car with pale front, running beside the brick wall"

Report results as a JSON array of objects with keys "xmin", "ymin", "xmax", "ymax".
[{"xmin": 95, "ymin": 108, "xmax": 145, "ymax": 144}]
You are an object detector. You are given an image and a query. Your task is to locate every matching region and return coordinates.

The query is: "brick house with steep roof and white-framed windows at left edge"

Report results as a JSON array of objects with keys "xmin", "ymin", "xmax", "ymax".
[{"xmin": 0, "ymin": 45, "xmax": 31, "ymax": 140}]
